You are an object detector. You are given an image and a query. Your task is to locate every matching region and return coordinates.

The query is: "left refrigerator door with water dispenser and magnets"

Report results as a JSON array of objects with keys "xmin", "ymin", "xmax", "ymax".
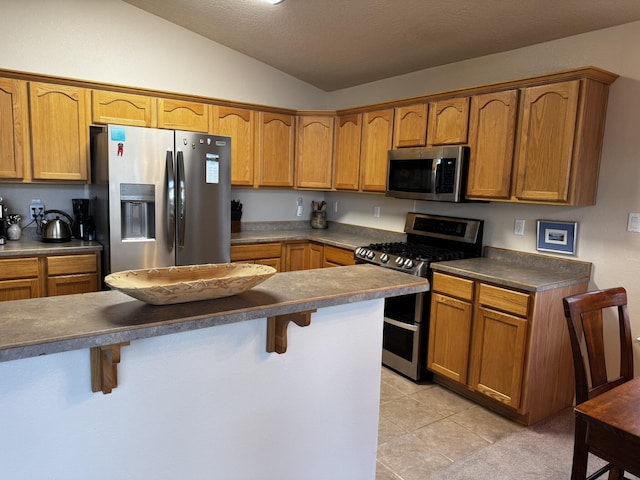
[{"xmin": 105, "ymin": 125, "xmax": 175, "ymax": 273}]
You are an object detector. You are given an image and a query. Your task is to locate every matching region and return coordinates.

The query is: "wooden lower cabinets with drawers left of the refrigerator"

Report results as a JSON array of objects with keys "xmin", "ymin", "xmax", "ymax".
[{"xmin": 0, "ymin": 253, "xmax": 100, "ymax": 301}]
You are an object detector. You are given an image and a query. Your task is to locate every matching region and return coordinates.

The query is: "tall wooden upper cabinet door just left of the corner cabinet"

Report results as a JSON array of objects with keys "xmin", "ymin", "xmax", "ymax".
[{"xmin": 256, "ymin": 112, "xmax": 295, "ymax": 187}]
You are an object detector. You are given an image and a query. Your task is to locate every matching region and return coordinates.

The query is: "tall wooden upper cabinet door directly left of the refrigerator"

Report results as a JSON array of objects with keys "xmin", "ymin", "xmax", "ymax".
[{"xmin": 29, "ymin": 82, "xmax": 91, "ymax": 182}]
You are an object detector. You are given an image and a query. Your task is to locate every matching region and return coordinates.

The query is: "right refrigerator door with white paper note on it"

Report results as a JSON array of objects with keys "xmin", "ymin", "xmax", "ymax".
[{"xmin": 176, "ymin": 131, "xmax": 231, "ymax": 265}]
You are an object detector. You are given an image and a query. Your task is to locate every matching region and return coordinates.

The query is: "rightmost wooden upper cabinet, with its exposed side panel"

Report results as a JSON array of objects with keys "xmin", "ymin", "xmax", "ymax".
[{"xmin": 515, "ymin": 80, "xmax": 596, "ymax": 205}]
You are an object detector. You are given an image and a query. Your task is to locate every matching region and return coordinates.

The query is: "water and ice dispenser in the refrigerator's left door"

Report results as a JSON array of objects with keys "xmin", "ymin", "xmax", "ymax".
[{"xmin": 120, "ymin": 183, "xmax": 156, "ymax": 241}]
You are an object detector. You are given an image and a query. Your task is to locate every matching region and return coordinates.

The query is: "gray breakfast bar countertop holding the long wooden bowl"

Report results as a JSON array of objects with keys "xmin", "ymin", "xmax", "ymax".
[{"xmin": 0, "ymin": 265, "xmax": 429, "ymax": 361}]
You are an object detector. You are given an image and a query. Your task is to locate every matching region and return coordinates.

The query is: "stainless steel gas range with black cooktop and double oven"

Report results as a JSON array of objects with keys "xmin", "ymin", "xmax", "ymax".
[{"xmin": 354, "ymin": 212, "xmax": 484, "ymax": 380}]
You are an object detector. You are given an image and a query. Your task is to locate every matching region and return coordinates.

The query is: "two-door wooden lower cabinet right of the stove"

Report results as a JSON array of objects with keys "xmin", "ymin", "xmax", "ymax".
[{"xmin": 427, "ymin": 272, "xmax": 587, "ymax": 425}]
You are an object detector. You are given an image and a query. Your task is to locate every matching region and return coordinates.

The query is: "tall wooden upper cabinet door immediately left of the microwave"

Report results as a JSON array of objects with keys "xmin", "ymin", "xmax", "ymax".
[{"xmin": 360, "ymin": 109, "xmax": 393, "ymax": 192}]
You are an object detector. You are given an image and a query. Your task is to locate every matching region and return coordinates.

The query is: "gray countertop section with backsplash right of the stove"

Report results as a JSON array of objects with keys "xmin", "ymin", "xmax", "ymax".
[{"xmin": 431, "ymin": 247, "xmax": 591, "ymax": 292}]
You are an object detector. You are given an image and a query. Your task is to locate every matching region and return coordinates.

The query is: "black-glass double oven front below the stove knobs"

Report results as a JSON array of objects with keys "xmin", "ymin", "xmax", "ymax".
[{"xmin": 382, "ymin": 293, "xmax": 427, "ymax": 380}]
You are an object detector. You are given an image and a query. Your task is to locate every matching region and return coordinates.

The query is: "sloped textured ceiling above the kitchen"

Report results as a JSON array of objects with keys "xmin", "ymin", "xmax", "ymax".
[{"xmin": 124, "ymin": 0, "xmax": 640, "ymax": 91}]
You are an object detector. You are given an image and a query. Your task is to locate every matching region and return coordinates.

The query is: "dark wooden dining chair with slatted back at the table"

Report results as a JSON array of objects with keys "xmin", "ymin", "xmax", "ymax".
[{"xmin": 563, "ymin": 287, "xmax": 633, "ymax": 480}]
